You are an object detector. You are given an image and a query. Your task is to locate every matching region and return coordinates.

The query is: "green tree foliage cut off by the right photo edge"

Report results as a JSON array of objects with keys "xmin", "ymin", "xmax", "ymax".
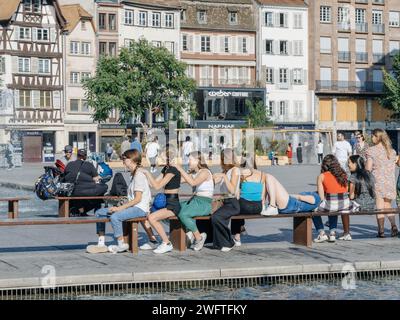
[{"xmin": 379, "ymin": 54, "xmax": 400, "ymax": 119}]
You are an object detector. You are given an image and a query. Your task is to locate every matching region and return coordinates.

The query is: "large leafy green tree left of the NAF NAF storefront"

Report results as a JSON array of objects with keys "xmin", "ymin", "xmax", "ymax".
[{"xmin": 83, "ymin": 40, "xmax": 196, "ymax": 125}]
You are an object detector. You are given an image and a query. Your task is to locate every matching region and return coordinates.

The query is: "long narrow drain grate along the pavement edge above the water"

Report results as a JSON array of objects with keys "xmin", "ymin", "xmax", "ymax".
[{"xmin": 0, "ymin": 270, "xmax": 400, "ymax": 300}]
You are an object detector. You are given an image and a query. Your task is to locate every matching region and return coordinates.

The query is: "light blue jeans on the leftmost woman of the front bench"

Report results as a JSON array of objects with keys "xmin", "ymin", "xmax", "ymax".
[{"xmin": 96, "ymin": 207, "xmax": 147, "ymax": 239}]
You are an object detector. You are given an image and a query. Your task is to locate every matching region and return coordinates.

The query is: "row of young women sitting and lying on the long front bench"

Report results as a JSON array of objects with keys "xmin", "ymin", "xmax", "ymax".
[{"xmin": 87, "ymin": 129, "xmax": 390, "ymax": 254}]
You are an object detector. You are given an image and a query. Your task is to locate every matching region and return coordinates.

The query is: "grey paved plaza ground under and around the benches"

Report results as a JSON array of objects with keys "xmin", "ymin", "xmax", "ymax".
[{"xmin": 0, "ymin": 166, "xmax": 400, "ymax": 288}]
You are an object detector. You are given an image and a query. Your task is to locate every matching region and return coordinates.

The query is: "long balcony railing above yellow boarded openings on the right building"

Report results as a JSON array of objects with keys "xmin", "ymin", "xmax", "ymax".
[{"xmin": 316, "ymin": 80, "xmax": 383, "ymax": 93}]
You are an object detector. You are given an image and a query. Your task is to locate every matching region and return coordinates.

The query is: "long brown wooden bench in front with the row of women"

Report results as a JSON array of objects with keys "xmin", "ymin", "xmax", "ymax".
[{"xmin": 0, "ymin": 208, "xmax": 400, "ymax": 254}]
